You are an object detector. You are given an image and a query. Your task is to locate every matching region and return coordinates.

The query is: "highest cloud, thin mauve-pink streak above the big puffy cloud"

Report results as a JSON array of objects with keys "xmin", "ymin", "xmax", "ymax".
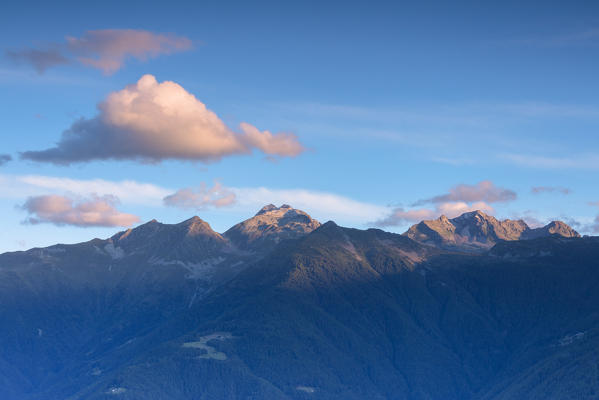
[{"xmin": 6, "ymin": 29, "xmax": 192, "ymax": 75}]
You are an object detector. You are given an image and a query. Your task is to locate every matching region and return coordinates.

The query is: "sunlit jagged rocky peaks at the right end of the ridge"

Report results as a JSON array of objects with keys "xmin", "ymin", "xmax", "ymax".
[{"xmin": 404, "ymin": 211, "xmax": 580, "ymax": 252}]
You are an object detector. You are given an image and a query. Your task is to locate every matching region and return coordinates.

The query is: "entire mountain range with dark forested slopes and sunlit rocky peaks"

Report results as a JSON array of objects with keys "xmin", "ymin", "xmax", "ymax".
[{"xmin": 0, "ymin": 205, "xmax": 599, "ymax": 400}]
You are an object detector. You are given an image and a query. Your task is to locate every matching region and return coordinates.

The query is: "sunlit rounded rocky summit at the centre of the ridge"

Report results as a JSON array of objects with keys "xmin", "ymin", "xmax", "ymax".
[{"xmin": 224, "ymin": 204, "xmax": 320, "ymax": 250}]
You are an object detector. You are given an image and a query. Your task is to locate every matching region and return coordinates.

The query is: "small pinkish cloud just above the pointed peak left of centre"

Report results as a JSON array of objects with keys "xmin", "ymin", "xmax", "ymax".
[{"xmin": 163, "ymin": 182, "xmax": 236, "ymax": 210}]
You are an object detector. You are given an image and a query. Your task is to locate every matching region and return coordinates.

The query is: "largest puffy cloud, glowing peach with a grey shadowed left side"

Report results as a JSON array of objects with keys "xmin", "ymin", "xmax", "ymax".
[{"xmin": 21, "ymin": 75, "xmax": 304, "ymax": 165}]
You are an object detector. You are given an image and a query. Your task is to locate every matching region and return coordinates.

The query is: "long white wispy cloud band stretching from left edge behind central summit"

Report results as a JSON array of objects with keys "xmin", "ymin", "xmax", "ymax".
[{"xmin": 0, "ymin": 174, "xmax": 390, "ymax": 225}]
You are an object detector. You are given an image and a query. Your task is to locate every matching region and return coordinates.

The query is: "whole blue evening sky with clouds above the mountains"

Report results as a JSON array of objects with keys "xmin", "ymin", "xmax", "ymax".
[{"xmin": 0, "ymin": 1, "xmax": 599, "ymax": 252}]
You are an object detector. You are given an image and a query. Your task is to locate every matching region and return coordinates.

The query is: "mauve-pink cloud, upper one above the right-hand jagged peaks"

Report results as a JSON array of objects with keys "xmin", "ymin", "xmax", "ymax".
[{"xmin": 414, "ymin": 181, "xmax": 517, "ymax": 206}]
